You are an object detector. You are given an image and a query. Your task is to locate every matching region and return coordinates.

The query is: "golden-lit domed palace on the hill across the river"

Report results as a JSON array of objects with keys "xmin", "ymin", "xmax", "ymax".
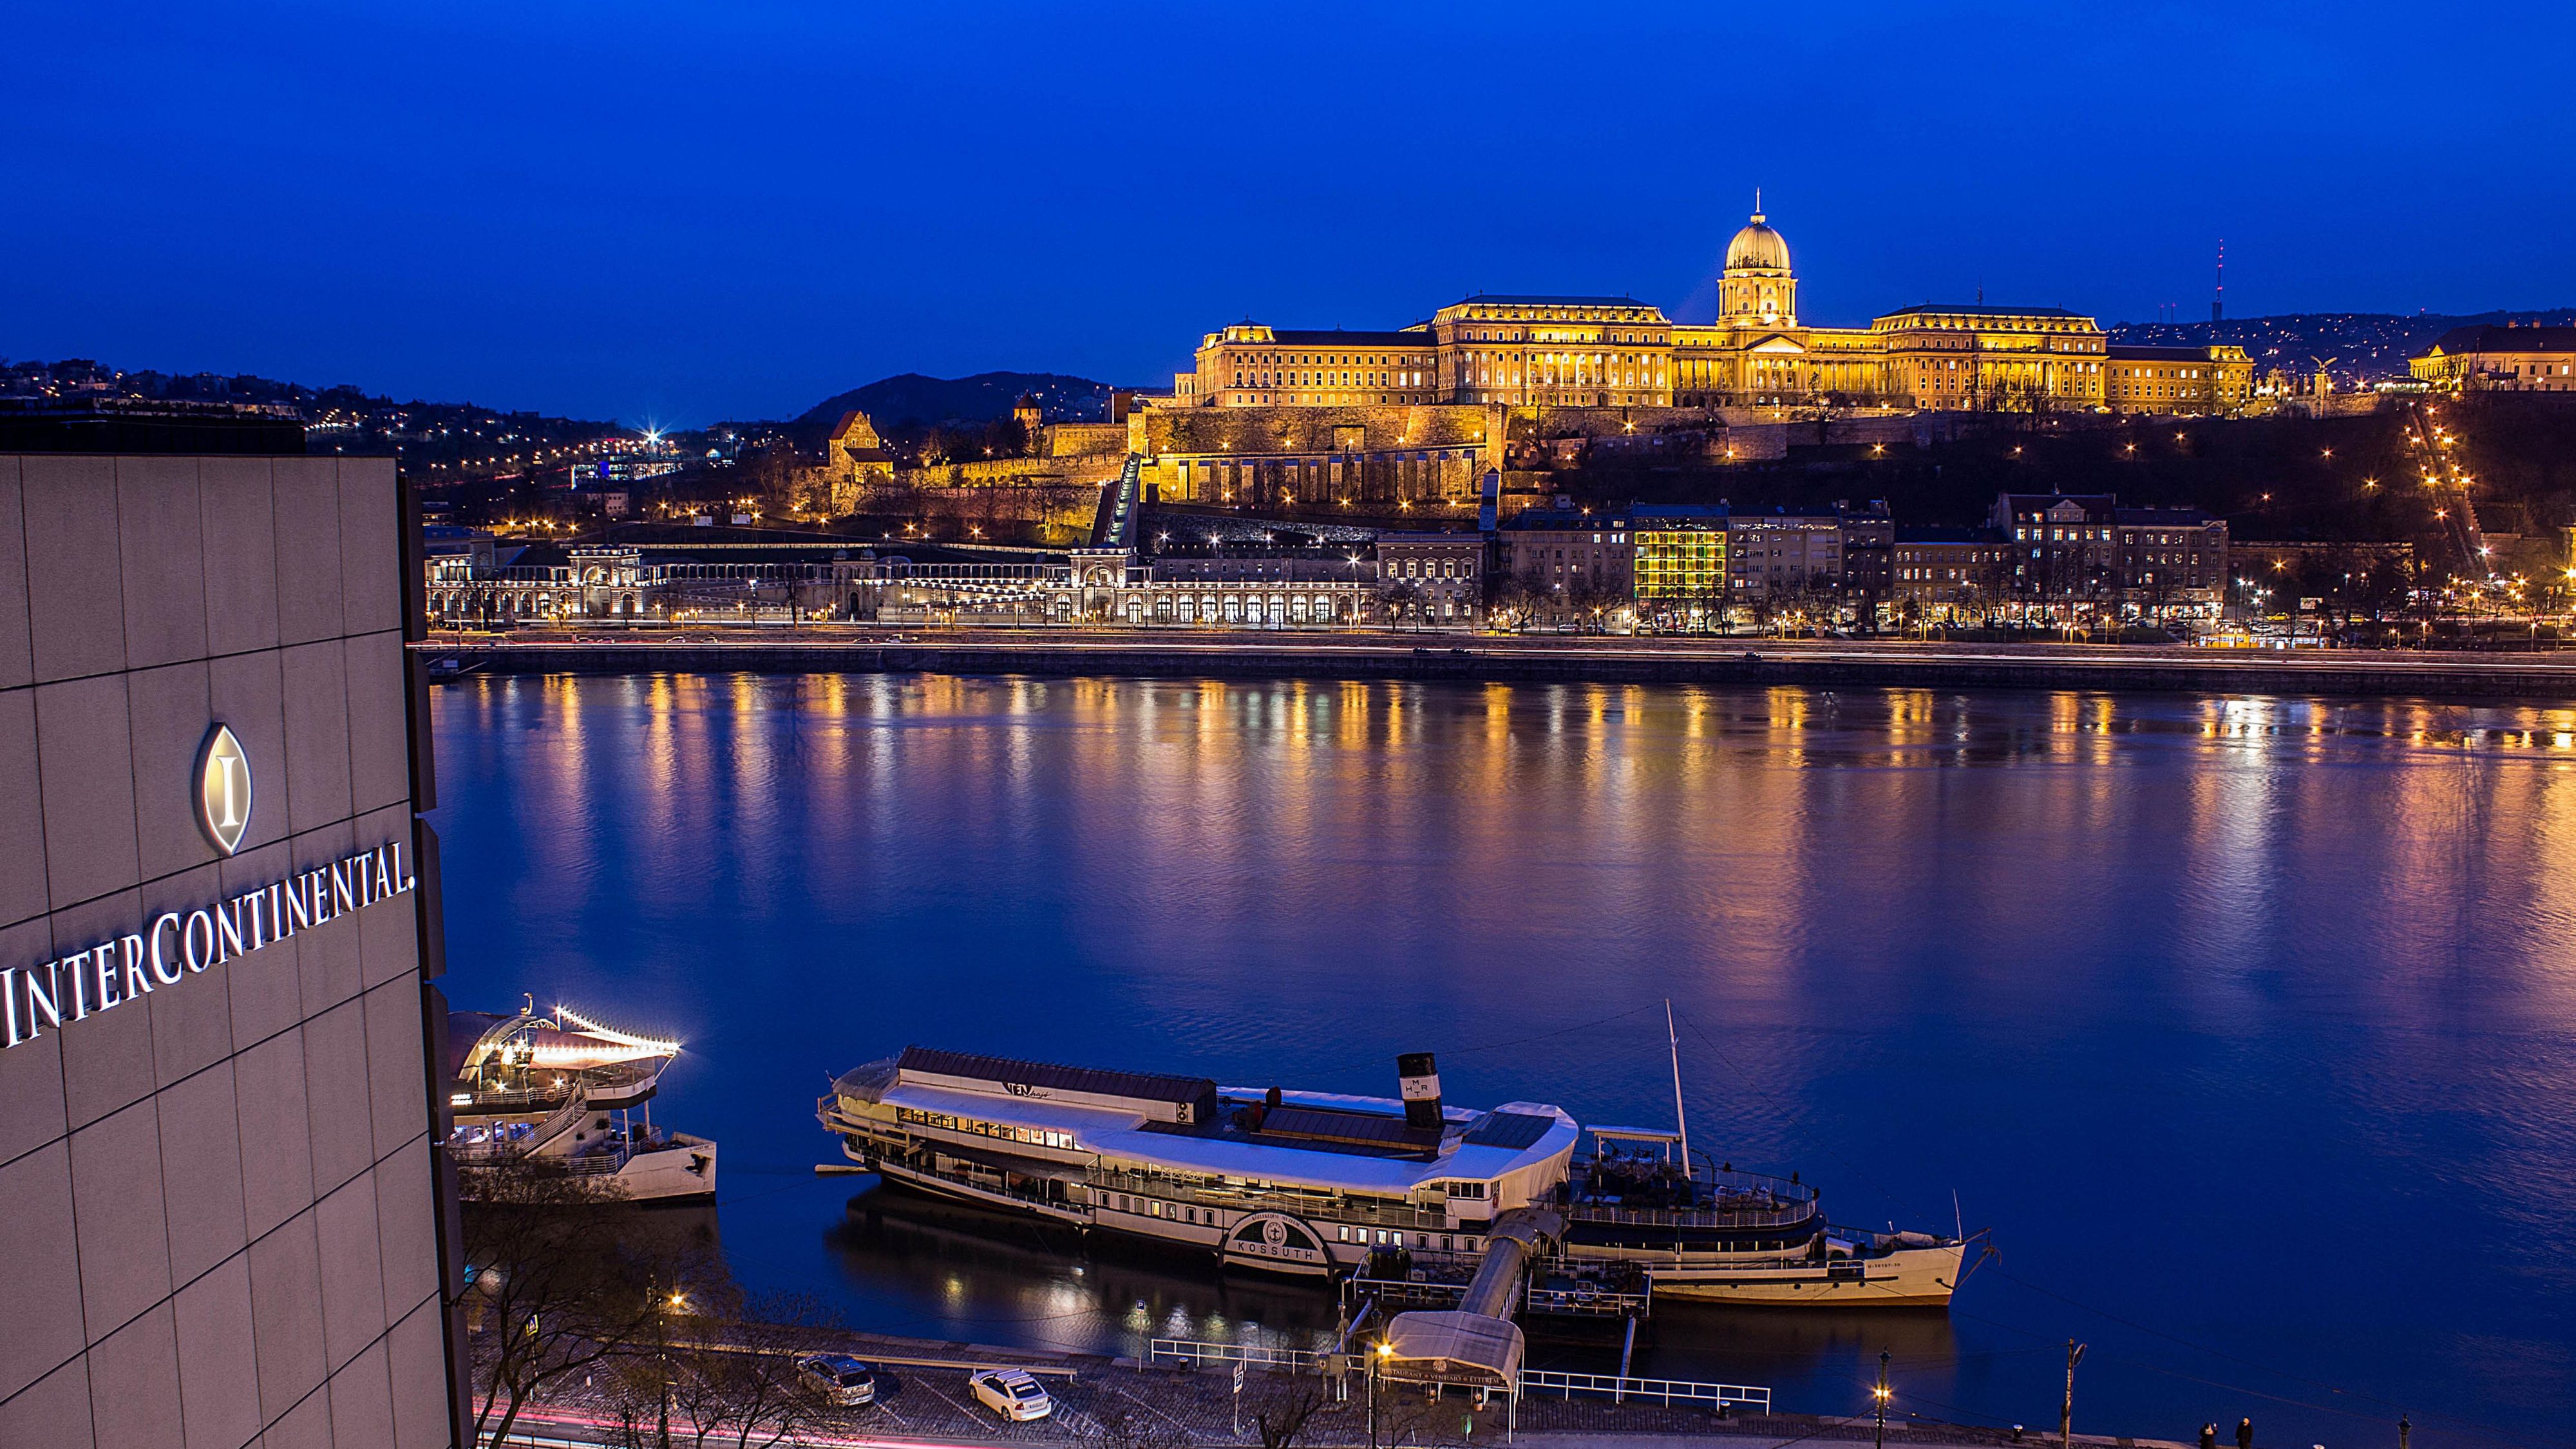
[{"xmin": 1172, "ymin": 209, "xmax": 2254, "ymax": 413}]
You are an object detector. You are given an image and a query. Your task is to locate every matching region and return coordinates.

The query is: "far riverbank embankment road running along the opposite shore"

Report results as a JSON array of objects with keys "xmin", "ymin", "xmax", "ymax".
[{"xmin": 415, "ymin": 624, "xmax": 2576, "ymax": 704}]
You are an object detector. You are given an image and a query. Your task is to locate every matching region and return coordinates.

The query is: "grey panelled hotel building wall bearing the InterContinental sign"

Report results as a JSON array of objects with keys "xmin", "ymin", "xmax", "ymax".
[{"xmin": 0, "ymin": 421, "xmax": 456, "ymax": 1449}]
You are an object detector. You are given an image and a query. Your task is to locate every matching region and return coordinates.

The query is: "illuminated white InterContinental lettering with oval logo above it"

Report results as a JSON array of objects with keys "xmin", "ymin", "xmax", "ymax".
[{"xmin": 0, "ymin": 724, "xmax": 415, "ymax": 1046}]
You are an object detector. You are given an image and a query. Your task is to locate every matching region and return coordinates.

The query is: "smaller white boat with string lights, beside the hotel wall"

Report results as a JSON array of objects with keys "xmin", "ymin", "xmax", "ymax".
[{"xmin": 448, "ymin": 998, "xmax": 716, "ymax": 1202}]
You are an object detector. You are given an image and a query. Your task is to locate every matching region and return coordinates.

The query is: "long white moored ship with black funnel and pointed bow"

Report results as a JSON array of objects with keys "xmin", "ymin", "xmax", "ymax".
[{"xmin": 817, "ymin": 1046, "xmax": 1963, "ymax": 1307}]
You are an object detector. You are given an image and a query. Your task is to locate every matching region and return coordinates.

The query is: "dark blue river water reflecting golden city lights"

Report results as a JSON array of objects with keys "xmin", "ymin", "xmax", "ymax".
[{"xmin": 435, "ymin": 676, "xmax": 2576, "ymax": 1449}]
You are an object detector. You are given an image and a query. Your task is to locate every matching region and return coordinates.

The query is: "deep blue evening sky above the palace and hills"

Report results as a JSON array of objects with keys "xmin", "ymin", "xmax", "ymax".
[{"xmin": 0, "ymin": 0, "xmax": 2576, "ymax": 423}]
